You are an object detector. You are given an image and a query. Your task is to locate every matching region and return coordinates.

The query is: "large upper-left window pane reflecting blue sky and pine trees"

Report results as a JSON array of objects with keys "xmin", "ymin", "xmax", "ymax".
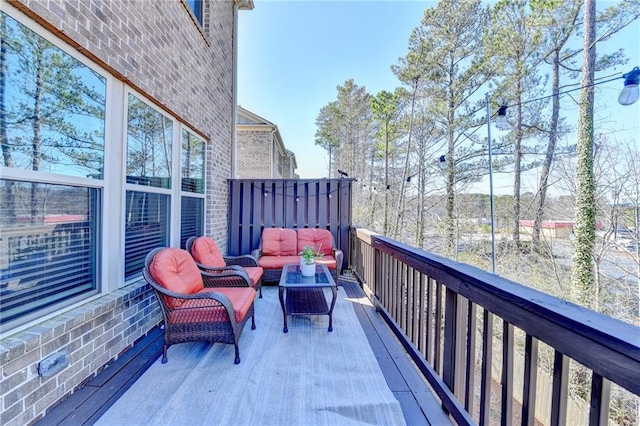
[{"xmin": 0, "ymin": 12, "xmax": 106, "ymax": 179}]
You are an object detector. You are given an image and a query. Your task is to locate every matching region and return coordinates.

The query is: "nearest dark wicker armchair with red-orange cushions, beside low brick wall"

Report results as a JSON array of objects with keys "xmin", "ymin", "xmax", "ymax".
[{"xmin": 143, "ymin": 247, "xmax": 256, "ymax": 364}]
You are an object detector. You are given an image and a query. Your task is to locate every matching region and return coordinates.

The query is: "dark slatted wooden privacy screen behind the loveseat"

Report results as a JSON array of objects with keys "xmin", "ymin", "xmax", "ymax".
[{"xmin": 227, "ymin": 179, "xmax": 353, "ymax": 268}]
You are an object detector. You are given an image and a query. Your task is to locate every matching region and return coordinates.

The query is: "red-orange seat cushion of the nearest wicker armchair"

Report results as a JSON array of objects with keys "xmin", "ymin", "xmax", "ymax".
[{"xmin": 169, "ymin": 287, "xmax": 256, "ymax": 324}]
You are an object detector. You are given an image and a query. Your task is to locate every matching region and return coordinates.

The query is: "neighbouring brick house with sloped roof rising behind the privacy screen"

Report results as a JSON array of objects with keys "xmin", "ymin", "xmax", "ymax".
[{"xmin": 236, "ymin": 106, "xmax": 298, "ymax": 179}]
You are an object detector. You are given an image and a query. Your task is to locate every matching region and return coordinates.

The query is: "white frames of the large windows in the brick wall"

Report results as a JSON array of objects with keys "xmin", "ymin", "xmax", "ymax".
[{"xmin": 0, "ymin": 2, "xmax": 210, "ymax": 335}]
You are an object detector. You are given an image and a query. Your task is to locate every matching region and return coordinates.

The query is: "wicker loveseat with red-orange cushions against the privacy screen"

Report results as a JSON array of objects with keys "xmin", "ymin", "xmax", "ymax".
[{"xmin": 251, "ymin": 228, "xmax": 344, "ymax": 282}]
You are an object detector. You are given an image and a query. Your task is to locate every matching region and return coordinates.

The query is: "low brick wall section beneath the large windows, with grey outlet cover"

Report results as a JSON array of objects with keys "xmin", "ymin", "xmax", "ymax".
[{"xmin": 0, "ymin": 280, "xmax": 162, "ymax": 426}]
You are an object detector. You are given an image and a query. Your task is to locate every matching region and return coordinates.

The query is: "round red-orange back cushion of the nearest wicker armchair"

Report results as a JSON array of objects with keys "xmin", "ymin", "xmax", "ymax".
[{"xmin": 149, "ymin": 247, "xmax": 204, "ymax": 308}]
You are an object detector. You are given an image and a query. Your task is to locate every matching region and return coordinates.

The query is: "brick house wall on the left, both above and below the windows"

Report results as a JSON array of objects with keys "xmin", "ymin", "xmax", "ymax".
[{"xmin": 0, "ymin": 0, "xmax": 240, "ymax": 425}]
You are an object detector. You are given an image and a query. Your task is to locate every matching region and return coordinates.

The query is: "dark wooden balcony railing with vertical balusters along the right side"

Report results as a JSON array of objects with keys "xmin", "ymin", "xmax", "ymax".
[{"xmin": 350, "ymin": 229, "xmax": 640, "ymax": 425}]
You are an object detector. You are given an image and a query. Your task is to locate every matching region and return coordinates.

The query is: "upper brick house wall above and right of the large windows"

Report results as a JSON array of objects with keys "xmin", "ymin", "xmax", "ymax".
[{"xmin": 9, "ymin": 0, "xmax": 235, "ymax": 250}]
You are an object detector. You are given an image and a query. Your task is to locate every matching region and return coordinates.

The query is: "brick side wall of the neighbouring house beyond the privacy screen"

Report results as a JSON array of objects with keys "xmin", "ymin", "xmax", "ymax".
[{"xmin": 238, "ymin": 130, "xmax": 277, "ymax": 179}]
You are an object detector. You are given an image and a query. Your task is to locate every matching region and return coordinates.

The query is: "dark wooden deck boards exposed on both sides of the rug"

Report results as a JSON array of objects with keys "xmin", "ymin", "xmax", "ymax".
[{"xmin": 36, "ymin": 279, "xmax": 452, "ymax": 426}]
